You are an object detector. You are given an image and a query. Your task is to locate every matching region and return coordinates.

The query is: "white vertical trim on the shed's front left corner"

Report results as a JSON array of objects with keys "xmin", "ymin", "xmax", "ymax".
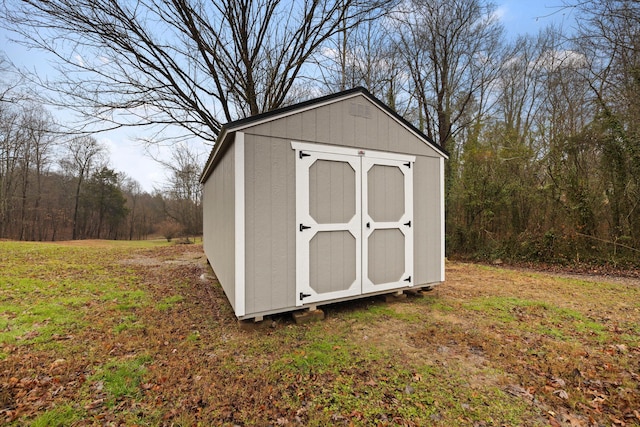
[{"xmin": 233, "ymin": 132, "xmax": 246, "ymax": 317}]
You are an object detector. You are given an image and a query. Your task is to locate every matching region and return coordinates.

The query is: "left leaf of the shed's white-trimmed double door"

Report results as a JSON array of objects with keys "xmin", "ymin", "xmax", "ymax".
[{"xmin": 296, "ymin": 151, "xmax": 362, "ymax": 305}]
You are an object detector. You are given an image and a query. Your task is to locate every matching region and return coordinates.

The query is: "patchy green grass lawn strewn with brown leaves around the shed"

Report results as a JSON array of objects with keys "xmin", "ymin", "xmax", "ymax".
[{"xmin": 0, "ymin": 241, "xmax": 640, "ymax": 426}]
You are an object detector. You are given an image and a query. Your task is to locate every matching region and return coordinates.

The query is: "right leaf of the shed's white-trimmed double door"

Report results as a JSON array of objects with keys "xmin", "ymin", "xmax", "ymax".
[{"xmin": 362, "ymin": 157, "xmax": 413, "ymax": 293}]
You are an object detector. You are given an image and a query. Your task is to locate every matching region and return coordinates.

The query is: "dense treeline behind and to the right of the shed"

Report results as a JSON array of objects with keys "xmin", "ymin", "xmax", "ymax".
[{"xmin": 321, "ymin": 0, "xmax": 640, "ymax": 265}]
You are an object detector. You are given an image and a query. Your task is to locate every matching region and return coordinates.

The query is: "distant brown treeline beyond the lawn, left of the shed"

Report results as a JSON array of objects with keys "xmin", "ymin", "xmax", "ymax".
[{"xmin": 0, "ymin": 95, "xmax": 202, "ymax": 241}]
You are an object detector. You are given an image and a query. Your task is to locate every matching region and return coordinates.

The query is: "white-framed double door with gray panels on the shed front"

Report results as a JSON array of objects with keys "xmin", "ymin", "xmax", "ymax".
[{"xmin": 292, "ymin": 143, "xmax": 415, "ymax": 306}]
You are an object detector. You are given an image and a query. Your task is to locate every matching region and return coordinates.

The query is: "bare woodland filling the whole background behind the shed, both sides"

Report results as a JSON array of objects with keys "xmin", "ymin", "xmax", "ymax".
[{"xmin": 0, "ymin": 0, "xmax": 640, "ymax": 267}]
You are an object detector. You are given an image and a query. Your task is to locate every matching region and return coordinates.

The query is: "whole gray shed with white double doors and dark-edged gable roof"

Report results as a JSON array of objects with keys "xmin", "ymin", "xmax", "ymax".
[{"xmin": 201, "ymin": 88, "xmax": 447, "ymax": 319}]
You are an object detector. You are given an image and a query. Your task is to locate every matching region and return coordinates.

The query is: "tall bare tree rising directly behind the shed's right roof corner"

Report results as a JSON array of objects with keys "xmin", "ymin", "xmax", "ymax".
[{"xmin": 394, "ymin": 0, "xmax": 502, "ymax": 153}]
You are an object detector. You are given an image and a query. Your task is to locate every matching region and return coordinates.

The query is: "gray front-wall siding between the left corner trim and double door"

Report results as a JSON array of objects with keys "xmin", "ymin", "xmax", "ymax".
[{"xmin": 245, "ymin": 134, "xmax": 296, "ymax": 315}]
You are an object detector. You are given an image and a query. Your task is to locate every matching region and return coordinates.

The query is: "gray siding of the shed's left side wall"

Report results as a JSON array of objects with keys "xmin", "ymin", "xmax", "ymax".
[{"xmin": 202, "ymin": 145, "xmax": 236, "ymax": 309}]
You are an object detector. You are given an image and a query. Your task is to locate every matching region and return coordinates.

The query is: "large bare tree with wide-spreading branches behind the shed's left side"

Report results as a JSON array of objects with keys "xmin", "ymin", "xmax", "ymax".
[{"xmin": 3, "ymin": 0, "xmax": 391, "ymax": 142}]
